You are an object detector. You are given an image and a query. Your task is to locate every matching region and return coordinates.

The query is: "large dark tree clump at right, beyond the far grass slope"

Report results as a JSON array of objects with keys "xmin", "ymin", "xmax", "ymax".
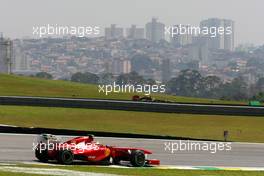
[{"xmin": 167, "ymin": 70, "xmax": 264, "ymax": 102}]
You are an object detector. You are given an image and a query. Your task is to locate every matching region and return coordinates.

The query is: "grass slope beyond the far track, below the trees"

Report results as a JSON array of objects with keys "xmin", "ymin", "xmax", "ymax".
[{"xmin": 0, "ymin": 74, "xmax": 245, "ymax": 104}]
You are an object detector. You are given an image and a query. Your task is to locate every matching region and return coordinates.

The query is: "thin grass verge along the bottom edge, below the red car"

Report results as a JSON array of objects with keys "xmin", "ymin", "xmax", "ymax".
[{"xmin": 0, "ymin": 165, "xmax": 263, "ymax": 176}]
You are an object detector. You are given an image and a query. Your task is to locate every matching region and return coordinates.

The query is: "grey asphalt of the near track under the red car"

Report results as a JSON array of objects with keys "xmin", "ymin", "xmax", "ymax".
[{"xmin": 0, "ymin": 134, "xmax": 264, "ymax": 167}]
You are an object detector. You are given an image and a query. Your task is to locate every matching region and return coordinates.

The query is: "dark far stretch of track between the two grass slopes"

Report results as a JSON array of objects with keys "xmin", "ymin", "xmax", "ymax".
[{"xmin": 0, "ymin": 96, "xmax": 264, "ymax": 116}]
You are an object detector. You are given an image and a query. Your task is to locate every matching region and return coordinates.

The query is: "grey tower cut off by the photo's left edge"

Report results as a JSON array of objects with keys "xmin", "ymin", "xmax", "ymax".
[{"xmin": 0, "ymin": 34, "xmax": 13, "ymax": 73}]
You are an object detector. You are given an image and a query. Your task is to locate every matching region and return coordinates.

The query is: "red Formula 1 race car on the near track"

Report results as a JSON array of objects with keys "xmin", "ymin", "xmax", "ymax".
[{"xmin": 35, "ymin": 134, "xmax": 160, "ymax": 167}]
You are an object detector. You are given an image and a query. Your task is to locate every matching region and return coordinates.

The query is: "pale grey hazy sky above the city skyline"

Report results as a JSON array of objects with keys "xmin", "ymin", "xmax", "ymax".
[{"xmin": 0, "ymin": 0, "xmax": 264, "ymax": 44}]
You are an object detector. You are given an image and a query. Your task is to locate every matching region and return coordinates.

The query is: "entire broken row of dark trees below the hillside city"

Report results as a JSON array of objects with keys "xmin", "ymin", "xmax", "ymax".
[{"xmin": 35, "ymin": 70, "xmax": 264, "ymax": 102}]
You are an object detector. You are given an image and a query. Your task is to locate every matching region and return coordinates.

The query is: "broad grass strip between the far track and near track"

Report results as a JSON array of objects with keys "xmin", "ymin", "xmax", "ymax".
[{"xmin": 0, "ymin": 106, "xmax": 264, "ymax": 142}]
